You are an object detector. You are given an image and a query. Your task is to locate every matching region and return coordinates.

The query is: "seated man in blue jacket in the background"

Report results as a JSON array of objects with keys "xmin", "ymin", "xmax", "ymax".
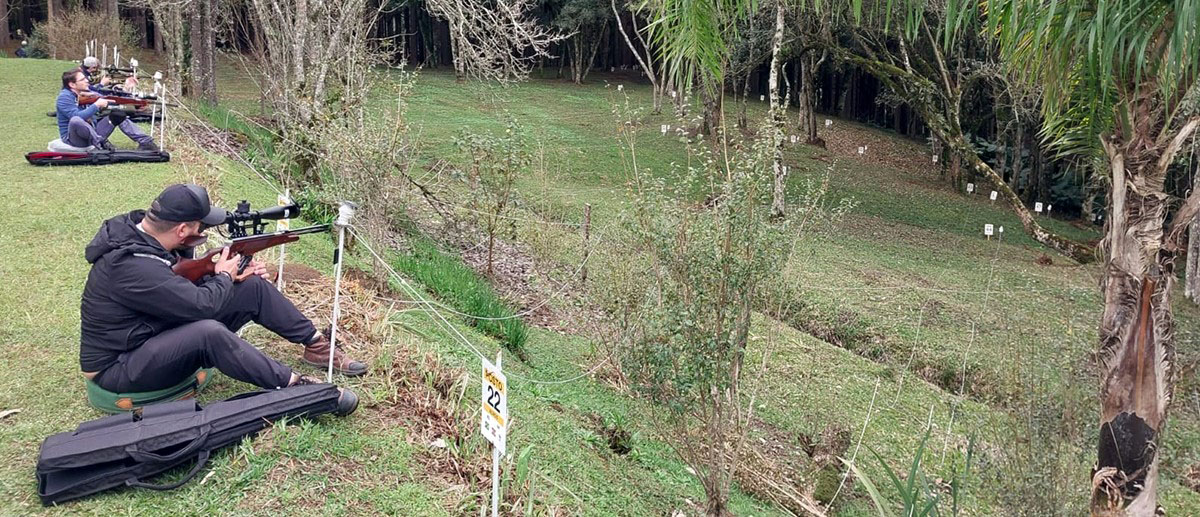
[{"xmin": 54, "ymin": 68, "xmax": 158, "ymax": 151}]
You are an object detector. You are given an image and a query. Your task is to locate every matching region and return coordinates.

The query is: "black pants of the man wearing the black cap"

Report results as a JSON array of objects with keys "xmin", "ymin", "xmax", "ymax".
[{"xmin": 92, "ymin": 276, "xmax": 317, "ymax": 392}]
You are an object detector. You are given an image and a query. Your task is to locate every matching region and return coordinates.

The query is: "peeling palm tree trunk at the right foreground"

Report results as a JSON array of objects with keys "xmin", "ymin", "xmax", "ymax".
[{"xmin": 1092, "ymin": 117, "xmax": 1200, "ymax": 517}]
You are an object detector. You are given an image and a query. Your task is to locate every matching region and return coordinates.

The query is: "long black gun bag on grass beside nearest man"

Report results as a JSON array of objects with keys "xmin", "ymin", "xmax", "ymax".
[{"xmin": 37, "ymin": 384, "xmax": 340, "ymax": 505}]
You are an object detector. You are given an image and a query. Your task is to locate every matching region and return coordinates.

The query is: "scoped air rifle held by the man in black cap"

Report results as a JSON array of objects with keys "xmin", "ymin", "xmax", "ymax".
[{"xmin": 170, "ymin": 200, "xmax": 330, "ymax": 282}]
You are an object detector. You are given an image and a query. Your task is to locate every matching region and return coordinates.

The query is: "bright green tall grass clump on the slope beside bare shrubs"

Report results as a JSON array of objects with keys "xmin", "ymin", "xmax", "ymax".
[{"xmin": 394, "ymin": 239, "xmax": 529, "ymax": 361}]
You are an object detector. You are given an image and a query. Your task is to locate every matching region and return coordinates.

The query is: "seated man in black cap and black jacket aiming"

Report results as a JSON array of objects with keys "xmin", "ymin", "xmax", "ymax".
[{"xmin": 79, "ymin": 185, "xmax": 366, "ymax": 414}]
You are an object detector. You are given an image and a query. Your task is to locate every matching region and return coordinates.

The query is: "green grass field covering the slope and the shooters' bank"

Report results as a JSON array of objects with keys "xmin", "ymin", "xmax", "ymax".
[{"xmin": 0, "ymin": 54, "xmax": 1200, "ymax": 516}]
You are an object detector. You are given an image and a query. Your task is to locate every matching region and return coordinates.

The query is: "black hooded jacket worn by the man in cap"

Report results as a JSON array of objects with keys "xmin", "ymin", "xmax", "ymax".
[{"xmin": 79, "ymin": 210, "xmax": 233, "ymax": 372}]
